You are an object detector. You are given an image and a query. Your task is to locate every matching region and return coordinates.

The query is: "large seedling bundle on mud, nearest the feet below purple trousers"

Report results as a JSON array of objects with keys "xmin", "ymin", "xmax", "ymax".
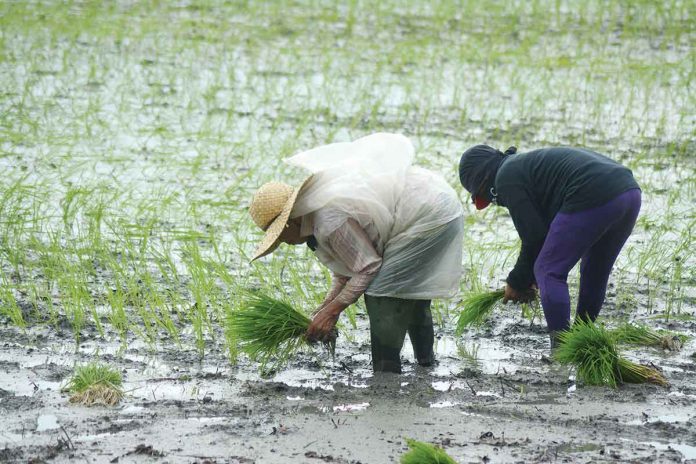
[{"xmin": 553, "ymin": 322, "xmax": 667, "ymax": 388}]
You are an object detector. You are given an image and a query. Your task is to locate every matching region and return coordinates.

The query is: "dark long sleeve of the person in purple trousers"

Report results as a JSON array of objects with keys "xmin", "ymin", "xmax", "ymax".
[{"xmin": 499, "ymin": 185, "xmax": 548, "ymax": 291}]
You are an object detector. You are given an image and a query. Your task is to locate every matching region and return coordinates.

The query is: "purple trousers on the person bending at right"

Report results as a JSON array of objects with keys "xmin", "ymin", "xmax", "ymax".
[{"xmin": 534, "ymin": 189, "xmax": 641, "ymax": 331}]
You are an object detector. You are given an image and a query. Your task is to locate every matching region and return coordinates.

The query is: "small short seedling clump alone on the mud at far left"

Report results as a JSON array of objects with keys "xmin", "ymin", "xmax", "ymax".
[{"xmin": 63, "ymin": 363, "xmax": 123, "ymax": 406}]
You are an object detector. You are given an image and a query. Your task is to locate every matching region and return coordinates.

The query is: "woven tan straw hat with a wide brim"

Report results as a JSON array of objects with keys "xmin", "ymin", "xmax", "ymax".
[{"xmin": 249, "ymin": 176, "xmax": 311, "ymax": 261}]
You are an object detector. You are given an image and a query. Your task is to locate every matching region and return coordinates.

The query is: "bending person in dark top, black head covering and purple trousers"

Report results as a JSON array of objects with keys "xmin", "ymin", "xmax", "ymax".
[{"xmin": 459, "ymin": 145, "xmax": 641, "ymax": 349}]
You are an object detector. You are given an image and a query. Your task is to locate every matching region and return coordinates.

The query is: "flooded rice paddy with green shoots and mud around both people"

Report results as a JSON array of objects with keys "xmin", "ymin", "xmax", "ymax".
[{"xmin": 0, "ymin": 0, "xmax": 696, "ymax": 464}]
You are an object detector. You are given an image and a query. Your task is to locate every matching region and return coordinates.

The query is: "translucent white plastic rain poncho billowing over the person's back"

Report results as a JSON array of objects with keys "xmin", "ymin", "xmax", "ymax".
[{"xmin": 286, "ymin": 133, "xmax": 463, "ymax": 299}]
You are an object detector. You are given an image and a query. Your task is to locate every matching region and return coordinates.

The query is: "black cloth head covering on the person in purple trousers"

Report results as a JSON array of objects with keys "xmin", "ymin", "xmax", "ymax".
[{"xmin": 459, "ymin": 145, "xmax": 517, "ymax": 200}]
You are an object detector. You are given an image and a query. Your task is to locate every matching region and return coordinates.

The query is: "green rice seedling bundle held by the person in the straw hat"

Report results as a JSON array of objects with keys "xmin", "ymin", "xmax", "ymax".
[{"xmin": 227, "ymin": 292, "xmax": 328, "ymax": 369}]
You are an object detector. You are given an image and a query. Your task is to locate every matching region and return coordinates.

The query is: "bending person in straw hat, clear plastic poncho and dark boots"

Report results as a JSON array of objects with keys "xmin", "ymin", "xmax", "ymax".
[{"xmin": 249, "ymin": 133, "xmax": 463, "ymax": 372}]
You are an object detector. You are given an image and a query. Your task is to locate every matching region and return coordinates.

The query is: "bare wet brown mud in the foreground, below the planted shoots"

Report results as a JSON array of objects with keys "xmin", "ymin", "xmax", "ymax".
[{"xmin": 0, "ymin": 310, "xmax": 696, "ymax": 463}]
